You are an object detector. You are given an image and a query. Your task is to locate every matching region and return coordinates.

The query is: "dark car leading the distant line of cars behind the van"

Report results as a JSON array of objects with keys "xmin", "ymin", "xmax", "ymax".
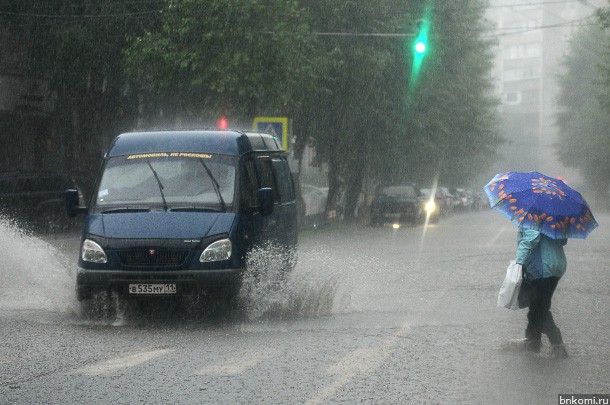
[{"xmin": 371, "ymin": 184, "xmax": 426, "ymax": 226}]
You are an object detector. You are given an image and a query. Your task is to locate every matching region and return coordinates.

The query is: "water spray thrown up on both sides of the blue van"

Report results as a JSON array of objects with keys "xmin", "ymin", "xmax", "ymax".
[{"xmin": 0, "ymin": 218, "xmax": 361, "ymax": 325}]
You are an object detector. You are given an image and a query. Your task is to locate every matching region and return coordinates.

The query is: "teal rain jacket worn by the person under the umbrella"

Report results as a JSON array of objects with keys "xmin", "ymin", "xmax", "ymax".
[{"xmin": 516, "ymin": 229, "xmax": 568, "ymax": 280}]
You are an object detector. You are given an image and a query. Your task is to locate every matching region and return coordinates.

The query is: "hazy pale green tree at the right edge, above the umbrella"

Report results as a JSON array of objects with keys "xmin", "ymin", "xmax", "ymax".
[{"xmin": 556, "ymin": 26, "xmax": 610, "ymax": 199}]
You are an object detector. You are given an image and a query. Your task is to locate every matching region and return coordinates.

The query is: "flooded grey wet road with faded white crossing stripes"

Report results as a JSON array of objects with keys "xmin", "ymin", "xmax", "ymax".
[{"xmin": 0, "ymin": 211, "xmax": 610, "ymax": 404}]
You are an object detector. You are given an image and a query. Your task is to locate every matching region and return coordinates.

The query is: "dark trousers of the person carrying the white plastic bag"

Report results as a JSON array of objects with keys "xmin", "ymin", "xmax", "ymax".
[{"xmin": 525, "ymin": 277, "xmax": 563, "ymax": 345}]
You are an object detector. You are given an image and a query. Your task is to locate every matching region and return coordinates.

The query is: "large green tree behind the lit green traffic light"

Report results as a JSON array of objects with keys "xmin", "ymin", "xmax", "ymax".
[{"xmin": 309, "ymin": 0, "xmax": 501, "ymax": 219}]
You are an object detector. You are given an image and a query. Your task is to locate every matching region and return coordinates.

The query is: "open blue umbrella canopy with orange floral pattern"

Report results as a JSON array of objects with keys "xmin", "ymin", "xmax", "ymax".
[{"xmin": 483, "ymin": 172, "xmax": 597, "ymax": 239}]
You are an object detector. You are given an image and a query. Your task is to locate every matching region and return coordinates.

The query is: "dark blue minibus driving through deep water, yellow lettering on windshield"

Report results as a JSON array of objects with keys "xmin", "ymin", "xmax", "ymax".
[{"xmin": 65, "ymin": 130, "xmax": 298, "ymax": 301}]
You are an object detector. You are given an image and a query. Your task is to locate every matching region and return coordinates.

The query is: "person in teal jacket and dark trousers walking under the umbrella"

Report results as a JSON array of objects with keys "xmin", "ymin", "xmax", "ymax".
[{"xmin": 516, "ymin": 228, "xmax": 568, "ymax": 358}]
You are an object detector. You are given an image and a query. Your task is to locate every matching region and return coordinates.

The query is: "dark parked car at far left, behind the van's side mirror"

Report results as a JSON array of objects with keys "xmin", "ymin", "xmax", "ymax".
[{"xmin": 0, "ymin": 171, "xmax": 84, "ymax": 232}]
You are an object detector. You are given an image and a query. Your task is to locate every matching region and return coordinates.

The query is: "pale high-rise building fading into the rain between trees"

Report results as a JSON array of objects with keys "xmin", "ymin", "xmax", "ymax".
[{"xmin": 488, "ymin": 0, "xmax": 605, "ymax": 181}]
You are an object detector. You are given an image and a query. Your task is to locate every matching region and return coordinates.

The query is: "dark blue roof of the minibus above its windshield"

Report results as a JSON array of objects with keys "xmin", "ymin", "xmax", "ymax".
[{"xmin": 106, "ymin": 130, "xmax": 283, "ymax": 157}]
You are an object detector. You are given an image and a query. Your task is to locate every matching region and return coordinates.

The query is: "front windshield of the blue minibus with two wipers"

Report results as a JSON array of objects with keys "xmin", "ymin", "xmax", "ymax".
[{"xmin": 95, "ymin": 152, "xmax": 237, "ymax": 211}]
